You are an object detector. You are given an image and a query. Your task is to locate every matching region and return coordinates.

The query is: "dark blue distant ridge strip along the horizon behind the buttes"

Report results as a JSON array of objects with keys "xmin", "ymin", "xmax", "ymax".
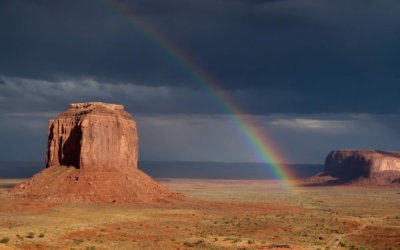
[{"xmin": 0, "ymin": 161, "xmax": 324, "ymax": 180}]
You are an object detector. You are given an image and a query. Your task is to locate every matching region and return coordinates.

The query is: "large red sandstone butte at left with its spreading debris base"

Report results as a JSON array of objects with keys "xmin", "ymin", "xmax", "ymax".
[{"xmin": 0, "ymin": 102, "xmax": 183, "ymax": 203}]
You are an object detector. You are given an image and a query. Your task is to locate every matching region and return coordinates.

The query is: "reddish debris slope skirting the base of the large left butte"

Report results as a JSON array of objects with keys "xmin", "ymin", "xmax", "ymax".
[{"xmin": 2, "ymin": 166, "xmax": 182, "ymax": 203}]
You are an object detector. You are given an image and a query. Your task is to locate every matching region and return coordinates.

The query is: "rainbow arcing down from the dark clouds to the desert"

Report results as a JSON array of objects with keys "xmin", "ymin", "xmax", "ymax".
[{"xmin": 93, "ymin": 0, "xmax": 295, "ymax": 189}]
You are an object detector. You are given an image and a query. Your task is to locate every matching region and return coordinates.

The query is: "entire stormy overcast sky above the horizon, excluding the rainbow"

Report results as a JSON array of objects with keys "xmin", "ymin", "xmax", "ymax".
[{"xmin": 0, "ymin": 0, "xmax": 400, "ymax": 164}]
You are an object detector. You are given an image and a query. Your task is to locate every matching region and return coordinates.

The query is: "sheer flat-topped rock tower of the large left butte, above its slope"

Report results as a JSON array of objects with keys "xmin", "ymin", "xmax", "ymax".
[{"xmin": 46, "ymin": 102, "xmax": 138, "ymax": 171}]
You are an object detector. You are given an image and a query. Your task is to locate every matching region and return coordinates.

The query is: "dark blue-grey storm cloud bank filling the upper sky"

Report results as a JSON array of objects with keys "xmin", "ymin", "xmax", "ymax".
[{"xmin": 0, "ymin": 0, "xmax": 400, "ymax": 114}]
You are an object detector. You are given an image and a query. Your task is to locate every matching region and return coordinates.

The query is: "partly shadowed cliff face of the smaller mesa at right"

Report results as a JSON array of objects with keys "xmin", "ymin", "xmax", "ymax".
[{"xmin": 325, "ymin": 150, "xmax": 400, "ymax": 178}]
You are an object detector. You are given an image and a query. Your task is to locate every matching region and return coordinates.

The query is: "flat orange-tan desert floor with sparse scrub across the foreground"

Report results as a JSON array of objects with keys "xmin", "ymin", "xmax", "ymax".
[{"xmin": 0, "ymin": 179, "xmax": 400, "ymax": 250}]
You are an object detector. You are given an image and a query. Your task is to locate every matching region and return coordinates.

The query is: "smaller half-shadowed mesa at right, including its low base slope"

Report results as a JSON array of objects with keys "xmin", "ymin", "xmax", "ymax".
[{"xmin": 306, "ymin": 150, "xmax": 400, "ymax": 186}]
